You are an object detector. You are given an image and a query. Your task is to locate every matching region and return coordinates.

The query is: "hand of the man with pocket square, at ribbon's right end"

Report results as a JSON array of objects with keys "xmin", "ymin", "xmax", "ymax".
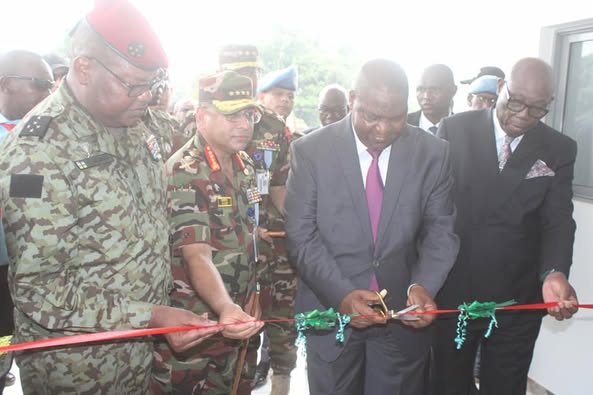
[{"xmin": 542, "ymin": 272, "xmax": 579, "ymax": 321}]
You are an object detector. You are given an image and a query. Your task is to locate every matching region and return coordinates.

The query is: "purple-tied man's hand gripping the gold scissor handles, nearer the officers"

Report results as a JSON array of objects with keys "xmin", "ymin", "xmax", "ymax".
[{"xmin": 339, "ymin": 289, "xmax": 387, "ymax": 329}]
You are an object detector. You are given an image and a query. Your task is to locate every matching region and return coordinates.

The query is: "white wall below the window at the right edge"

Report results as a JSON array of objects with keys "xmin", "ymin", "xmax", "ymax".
[{"xmin": 529, "ymin": 200, "xmax": 593, "ymax": 395}]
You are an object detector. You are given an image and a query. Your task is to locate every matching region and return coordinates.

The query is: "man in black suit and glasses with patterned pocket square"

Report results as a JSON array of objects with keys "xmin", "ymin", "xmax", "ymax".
[{"xmin": 434, "ymin": 58, "xmax": 577, "ymax": 395}]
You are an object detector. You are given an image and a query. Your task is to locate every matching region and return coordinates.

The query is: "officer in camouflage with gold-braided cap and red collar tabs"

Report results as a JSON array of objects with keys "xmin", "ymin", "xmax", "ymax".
[{"xmin": 155, "ymin": 71, "xmax": 263, "ymax": 395}]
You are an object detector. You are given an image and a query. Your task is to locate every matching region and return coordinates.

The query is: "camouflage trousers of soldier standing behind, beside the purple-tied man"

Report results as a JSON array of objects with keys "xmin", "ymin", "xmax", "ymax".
[{"xmin": 257, "ymin": 238, "xmax": 297, "ymax": 374}]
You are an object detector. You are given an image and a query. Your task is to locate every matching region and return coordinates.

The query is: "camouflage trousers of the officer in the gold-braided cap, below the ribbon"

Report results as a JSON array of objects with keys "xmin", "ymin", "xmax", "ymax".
[{"xmin": 153, "ymin": 336, "xmax": 259, "ymax": 395}]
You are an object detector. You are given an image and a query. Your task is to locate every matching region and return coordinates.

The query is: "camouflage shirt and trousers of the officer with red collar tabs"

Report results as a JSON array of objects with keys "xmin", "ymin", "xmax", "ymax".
[{"xmin": 154, "ymin": 134, "xmax": 257, "ymax": 394}]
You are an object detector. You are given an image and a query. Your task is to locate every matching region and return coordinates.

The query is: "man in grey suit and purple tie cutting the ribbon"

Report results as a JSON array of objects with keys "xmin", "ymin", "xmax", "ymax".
[{"xmin": 285, "ymin": 59, "xmax": 458, "ymax": 395}]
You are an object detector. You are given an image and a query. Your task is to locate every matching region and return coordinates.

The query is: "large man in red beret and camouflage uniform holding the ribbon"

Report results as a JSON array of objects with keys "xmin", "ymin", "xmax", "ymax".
[{"xmin": 0, "ymin": 0, "xmax": 229, "ymax": 395}]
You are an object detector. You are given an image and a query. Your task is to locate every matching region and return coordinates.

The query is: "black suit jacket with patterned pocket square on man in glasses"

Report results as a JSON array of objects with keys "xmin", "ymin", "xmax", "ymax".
[{"xmin": 437, "ymin": 109, "xmax": 576, "ymax": 308}]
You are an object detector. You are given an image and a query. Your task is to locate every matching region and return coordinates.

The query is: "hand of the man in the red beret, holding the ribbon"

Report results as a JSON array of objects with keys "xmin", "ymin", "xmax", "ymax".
[{"xmin": 149, "ymin": 305, "xmax": 222, "ymax": 352}]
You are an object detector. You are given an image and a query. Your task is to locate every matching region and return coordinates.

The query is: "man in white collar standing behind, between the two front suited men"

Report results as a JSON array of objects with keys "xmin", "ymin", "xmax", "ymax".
[{"xmin": 408, "ymin": 64, "xmax": 457, "ymax": 134}]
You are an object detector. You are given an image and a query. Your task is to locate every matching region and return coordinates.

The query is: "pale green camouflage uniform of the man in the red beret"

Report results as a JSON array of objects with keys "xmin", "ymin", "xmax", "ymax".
[{"xmin": 0, "ymin": 84, "xmax": 172, "ymax": 395}]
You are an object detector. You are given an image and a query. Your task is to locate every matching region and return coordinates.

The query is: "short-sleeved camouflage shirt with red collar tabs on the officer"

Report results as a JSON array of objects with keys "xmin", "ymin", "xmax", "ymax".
[{"xmin": 166, "ymin": 134, "xmax": 257, "ymax": 314}]
